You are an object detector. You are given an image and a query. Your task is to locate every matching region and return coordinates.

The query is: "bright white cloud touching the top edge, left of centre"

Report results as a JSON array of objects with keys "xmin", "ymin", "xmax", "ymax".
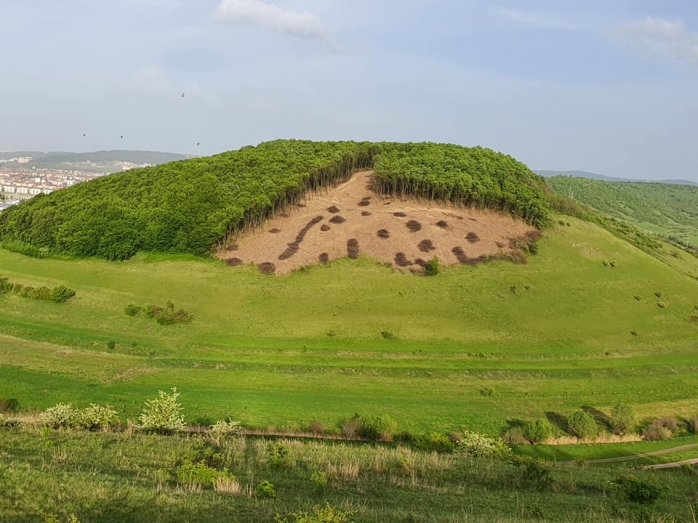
[{"xmin": 215, "ymin": 0, "xmax": 329, "ymax": 42}]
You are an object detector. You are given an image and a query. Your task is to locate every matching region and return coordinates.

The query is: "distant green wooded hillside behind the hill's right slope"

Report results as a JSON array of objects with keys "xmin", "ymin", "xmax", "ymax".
[{"xmin": 548, "ymin": 176, "xmax": 698, "ymax": 245}]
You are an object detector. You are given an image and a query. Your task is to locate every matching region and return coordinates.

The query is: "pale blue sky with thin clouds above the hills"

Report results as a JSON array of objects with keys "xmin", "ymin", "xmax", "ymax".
[{"xmin": 0, "ymin": 0, "xmax": 698, "ymax": 181}]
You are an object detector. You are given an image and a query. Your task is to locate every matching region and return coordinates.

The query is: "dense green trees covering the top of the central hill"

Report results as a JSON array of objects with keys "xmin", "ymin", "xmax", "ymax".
[{"xmin": 0, "ymin": 140, "xmax": 548, "ymax": 260}]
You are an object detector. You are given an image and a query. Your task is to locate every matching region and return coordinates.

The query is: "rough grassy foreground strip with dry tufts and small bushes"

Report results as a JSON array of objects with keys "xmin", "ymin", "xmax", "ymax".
[{"xmin": 0, "ymin": 428, "xmax": 698, "ymax": 523}]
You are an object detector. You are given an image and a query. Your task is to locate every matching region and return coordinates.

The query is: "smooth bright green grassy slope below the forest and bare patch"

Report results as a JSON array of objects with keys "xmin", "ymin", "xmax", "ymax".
[{"xmin": 0, "ymin": 219, "xmax": 698, "ymax": 433}]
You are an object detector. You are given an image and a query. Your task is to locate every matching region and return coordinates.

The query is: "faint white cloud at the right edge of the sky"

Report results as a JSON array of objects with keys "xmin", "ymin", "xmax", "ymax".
[{"xmin": 619, "ymin": 16, "xmax": 698, "ymax": 67}]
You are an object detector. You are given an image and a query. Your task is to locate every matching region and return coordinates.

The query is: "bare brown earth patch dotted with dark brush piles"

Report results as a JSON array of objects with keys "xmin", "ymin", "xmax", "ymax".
[{"xmin": 218, "ymin": 172, "xmax": 535, "ymax": 274}]
